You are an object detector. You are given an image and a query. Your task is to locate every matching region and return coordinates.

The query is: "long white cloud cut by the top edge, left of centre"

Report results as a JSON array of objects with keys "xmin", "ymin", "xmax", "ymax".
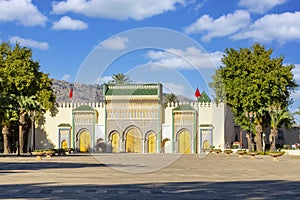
[{"xmin": 52, "ymin": 0, "xmax": 185, "ymax": 20}]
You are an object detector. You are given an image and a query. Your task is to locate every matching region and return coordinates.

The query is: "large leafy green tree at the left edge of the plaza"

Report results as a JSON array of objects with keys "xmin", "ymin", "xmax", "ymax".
[{"xmin": 0, "ymin": 43, "xmax": 55, "ymax": 153}]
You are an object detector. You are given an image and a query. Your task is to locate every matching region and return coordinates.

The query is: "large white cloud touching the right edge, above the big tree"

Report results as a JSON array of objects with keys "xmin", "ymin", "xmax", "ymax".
[{"xmin": 232, "ymin": 12, "xmax": 300, "ymax": 43}]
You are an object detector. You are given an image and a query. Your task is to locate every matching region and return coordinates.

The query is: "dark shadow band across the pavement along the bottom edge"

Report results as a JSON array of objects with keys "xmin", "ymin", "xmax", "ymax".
[{"xmin": 0, "ymin": 180, "xmax": 300, "ymax": 199}]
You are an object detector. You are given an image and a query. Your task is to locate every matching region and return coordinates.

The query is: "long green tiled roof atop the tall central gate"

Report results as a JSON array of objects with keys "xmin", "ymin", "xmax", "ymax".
[{"xmin": 105, "ymin": 84, "xmax": 159, "ymax": 96}]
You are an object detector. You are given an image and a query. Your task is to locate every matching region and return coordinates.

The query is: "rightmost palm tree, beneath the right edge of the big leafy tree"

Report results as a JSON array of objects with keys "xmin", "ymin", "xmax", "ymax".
[{"xmin": 269, "ymin": 106, "xmax": 293, "ymax": 151}]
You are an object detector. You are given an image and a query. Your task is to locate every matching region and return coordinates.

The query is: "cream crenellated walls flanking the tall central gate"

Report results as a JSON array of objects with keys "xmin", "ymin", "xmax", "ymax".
[{"xmin": 36, "ymin": 103, "xmax": 234, "ymax": 153}]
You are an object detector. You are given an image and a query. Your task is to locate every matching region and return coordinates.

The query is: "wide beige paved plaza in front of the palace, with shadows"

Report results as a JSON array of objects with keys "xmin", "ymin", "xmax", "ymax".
[{"xmin": 0, "ymin": 154, "xmax": 300, "ymax": 199}]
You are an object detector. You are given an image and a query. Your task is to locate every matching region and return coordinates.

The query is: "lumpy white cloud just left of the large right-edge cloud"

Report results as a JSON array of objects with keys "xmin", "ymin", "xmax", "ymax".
[{"xmin": 185, "ymin": 10, "xmax": 250, "ymax": 41}]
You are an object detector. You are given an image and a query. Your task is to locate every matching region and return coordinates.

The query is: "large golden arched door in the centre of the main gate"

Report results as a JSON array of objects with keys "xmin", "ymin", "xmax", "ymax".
[{"xmin": 126, "ymin": 128, "xmax": 142, "ymax": 153}]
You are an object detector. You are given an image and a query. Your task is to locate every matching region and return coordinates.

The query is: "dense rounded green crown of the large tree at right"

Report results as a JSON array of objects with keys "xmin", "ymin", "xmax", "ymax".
[{"xmin": 214, "ymin": 43, "xmax": 297, "ymax": 151}]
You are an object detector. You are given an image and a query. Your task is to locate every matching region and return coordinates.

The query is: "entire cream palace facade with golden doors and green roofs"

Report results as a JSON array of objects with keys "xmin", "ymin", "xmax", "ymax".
[{"xmin": 36, "ymin": 84, "xmax": 235, "ymax": 153}]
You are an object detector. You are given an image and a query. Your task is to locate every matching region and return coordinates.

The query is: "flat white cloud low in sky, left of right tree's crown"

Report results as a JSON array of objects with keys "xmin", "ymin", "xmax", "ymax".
[{"xmin": 147, "ymin": 47, "xmax": 223, "ymax": 70}]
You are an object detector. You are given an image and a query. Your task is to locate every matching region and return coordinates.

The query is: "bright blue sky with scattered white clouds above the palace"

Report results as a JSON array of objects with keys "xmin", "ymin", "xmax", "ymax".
[{"xmin": 0, "ymin": 0, "xmax": 300, "ymax": 120}]
